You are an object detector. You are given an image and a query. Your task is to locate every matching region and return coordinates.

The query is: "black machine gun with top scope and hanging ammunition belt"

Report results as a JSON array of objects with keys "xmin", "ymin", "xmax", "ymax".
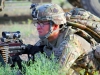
[{"xmin": 0, "ymin": 31, "xmax": 25, "ymax": 64}]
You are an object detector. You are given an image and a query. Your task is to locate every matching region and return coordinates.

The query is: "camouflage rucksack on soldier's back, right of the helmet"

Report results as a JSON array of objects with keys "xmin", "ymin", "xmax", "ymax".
[{"xmin": 66, "ymin": 8, "xmax": 100, "ymax": 35}]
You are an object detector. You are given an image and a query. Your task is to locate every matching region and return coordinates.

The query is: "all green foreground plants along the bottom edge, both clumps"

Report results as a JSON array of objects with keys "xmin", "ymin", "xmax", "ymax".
[{"xmin": 0, "ymin": 54, "xmax": 65, "ymax": 75}]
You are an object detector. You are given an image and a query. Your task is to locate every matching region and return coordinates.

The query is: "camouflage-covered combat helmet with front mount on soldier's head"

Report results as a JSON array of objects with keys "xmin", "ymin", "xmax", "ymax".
[{"xmin": 32, "ymin": 4, "xmax": 66, "ymax": 25}]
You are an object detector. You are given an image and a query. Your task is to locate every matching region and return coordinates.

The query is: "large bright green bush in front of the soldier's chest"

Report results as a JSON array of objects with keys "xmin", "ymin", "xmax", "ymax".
[{"xmin": 24, "ymin": 54, "xmax": 64, "ymax": 75}]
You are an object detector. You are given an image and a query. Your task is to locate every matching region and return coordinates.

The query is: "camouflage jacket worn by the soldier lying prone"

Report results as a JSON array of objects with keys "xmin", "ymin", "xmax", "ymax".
[{"xmin": 36, "ymin": 27, "xmax": 99, "ymax": 75}]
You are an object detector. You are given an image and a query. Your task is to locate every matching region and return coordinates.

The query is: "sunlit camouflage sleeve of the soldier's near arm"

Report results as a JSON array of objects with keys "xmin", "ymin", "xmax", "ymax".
[{"xmin": 60, "ymin": 36, "xmax": 84, "ymax": 73}]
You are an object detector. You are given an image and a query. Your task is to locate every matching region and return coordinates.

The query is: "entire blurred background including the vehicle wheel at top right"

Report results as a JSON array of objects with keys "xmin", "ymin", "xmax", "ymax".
[{"xmin": 0, "ymin": 0, "xmax": 100, "ymax": 44}]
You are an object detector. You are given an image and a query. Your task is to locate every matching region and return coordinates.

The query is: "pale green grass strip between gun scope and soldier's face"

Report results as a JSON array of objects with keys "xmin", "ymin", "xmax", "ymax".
[{"xmin": 0, "ymin": 19, "xmax": 37, "ymax": 38}]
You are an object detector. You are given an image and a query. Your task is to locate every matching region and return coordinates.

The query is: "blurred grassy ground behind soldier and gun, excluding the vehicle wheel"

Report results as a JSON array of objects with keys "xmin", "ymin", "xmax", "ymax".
[{"xmin": 0, "ymin": 0, "xmax": 72, "ymax": 44}]
